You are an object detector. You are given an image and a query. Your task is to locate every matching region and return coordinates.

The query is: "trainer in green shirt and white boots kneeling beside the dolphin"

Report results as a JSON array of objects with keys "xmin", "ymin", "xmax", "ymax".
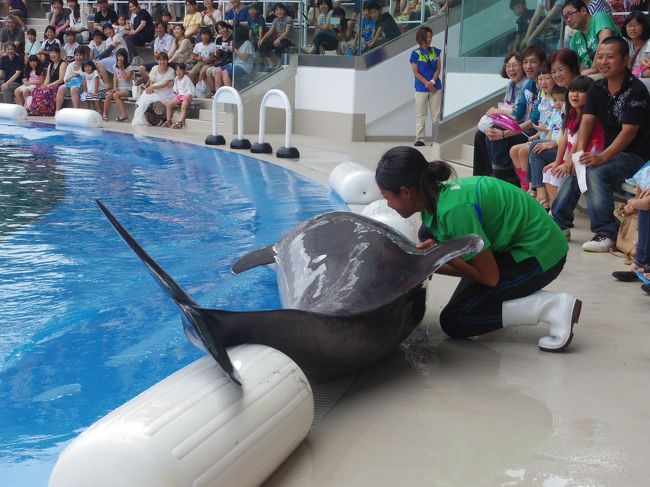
[{"xmin": 375, "ymin": 147, "xmax": 582, "ymax": 352}]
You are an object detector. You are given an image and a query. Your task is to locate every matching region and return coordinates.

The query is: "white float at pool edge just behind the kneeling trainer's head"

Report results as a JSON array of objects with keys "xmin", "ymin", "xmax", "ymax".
[{"xmin": 329, "ymin": 162, "xmax": 381, "ymax": 205}]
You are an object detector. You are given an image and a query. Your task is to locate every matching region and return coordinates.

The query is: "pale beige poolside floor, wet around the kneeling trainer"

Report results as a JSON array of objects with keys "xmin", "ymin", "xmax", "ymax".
[{"xmin": 39, "ymin": 119, "xmax": 650, "ymax": 487}]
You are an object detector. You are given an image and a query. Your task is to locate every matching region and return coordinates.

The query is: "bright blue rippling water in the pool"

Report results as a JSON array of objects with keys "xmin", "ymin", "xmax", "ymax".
[{"xmin": 0, "ymin": 125, "xmax": 345, "ymax": 487}]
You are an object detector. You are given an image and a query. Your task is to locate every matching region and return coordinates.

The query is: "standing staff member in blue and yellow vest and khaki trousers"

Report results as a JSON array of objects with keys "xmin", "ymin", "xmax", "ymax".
[{"xmin": 411, "ymin": 27, "xmax": 442, "ymax": 147}]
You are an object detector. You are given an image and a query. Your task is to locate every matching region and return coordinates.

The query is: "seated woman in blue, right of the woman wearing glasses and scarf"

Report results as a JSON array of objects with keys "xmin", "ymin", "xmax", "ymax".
[{"xmin": 485, "ymin": 46, "xmax": 546, "ymax": 186}]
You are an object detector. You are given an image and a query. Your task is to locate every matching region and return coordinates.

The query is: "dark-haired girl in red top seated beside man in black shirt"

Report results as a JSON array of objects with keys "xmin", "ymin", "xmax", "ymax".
[{"xmin": 543, "ymin": 76, "xmax": 605, "ymax": 205}]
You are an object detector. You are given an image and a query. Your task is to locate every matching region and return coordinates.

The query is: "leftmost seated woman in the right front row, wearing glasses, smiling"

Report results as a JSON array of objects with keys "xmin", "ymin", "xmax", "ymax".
[{"xmin": 472, "ymin": 52, "xmax": 528, "ymax": 176}]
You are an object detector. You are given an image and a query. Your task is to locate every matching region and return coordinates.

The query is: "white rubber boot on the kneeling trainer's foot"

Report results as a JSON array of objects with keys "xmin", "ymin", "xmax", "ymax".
[{"xmin": 502, "ymin": 291, "xmax": 582, "ymax": 352}]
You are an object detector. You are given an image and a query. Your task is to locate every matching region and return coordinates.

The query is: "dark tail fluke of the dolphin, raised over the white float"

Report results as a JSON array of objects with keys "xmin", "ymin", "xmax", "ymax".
[{"xmin": 96, "ymin": 200, "xmax": 241, "ymax": 385}]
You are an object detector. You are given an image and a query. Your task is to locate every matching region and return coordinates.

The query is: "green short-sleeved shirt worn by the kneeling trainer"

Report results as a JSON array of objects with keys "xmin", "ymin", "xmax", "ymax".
[{"xmin": 422, "ymin": 176, "xmax": 569, "ymax": 271}]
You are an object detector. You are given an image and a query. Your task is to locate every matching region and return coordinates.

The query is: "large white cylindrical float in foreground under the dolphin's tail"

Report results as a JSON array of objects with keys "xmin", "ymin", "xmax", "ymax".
[{"xmin": 49, "ymin": 345, "xmax": 314, "ymax": 487}]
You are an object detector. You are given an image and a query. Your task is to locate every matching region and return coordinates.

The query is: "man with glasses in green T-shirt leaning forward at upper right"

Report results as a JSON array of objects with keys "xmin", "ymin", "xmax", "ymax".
[{"xmin": 562, "ymin": 0, "xmax": 619, "ymax": 76}]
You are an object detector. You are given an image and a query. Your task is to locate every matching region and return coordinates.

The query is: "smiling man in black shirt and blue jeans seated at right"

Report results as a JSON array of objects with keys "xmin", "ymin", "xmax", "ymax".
[{"xmin": 551, "ymin": 37, "xmax": 650, "ymax": 252}]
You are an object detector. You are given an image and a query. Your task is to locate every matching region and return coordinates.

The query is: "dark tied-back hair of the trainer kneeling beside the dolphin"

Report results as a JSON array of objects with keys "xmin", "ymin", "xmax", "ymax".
[{"xmin": 375, "ymin": 146, "xmax": 456, "ymax": 220}]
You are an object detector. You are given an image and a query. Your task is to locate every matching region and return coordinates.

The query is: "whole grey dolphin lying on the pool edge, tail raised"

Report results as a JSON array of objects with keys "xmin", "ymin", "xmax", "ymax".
[{"xmin": 97, "ymin": 200, "xmax": 483, "ymax": 384}]
